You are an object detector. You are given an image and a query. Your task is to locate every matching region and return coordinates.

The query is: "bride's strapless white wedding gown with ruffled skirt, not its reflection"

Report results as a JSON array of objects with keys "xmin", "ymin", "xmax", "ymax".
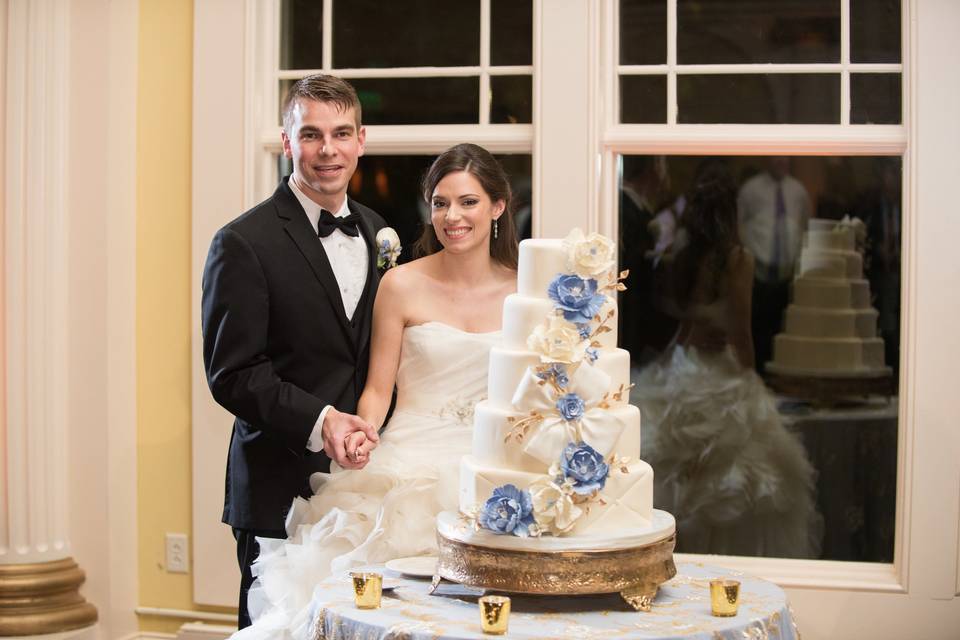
[{"xmin": 233, "ymin": 322, "xmax": 500, "ymax": 640}]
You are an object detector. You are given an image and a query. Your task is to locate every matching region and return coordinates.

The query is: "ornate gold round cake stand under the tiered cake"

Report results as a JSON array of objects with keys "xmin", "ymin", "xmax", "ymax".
[{"xmin": 431, "ymin": 531, "xmax": 677, "ymax": 611}]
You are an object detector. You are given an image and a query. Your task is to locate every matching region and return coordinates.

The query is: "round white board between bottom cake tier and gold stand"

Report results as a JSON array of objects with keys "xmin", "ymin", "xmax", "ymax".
[{"xmin": 437, "ymin": 509, "xmax": 676, "ymax": 552}]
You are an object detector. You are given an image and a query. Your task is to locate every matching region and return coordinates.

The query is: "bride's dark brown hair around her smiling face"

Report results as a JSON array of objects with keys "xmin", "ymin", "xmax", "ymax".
[{"xmin": 413, "ymin": 143, "xmax": 517, "ymax": 270}]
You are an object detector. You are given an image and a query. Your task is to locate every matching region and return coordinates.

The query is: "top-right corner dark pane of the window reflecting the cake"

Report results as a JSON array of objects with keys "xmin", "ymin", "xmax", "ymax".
[{"xmin": 850, "ymin": 0, "xmax": 900, "ymax": 62}]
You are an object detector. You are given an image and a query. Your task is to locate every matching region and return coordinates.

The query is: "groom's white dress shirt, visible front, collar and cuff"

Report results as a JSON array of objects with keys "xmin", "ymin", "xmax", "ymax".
[{"xmin": 288, "ymin": 178, "xmax": 368, "ymax": 452}]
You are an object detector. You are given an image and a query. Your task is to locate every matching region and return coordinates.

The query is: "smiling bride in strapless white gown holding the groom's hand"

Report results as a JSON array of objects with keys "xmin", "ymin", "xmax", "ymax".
[{"xmin": 233, "ymin": 144, "xmax": 517, "ymax": 640}]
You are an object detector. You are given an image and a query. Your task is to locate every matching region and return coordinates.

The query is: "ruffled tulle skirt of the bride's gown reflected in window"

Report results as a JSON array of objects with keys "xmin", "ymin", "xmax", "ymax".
[{"xmin": 630, "ymin": 345, "xmax": 823, "ymax": 558}]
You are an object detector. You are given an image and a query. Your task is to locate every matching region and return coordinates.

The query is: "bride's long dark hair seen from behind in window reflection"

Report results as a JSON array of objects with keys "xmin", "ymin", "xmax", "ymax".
[{"xmin": 672, "ymin": 158, "xmax": 741, "ymax": 310}]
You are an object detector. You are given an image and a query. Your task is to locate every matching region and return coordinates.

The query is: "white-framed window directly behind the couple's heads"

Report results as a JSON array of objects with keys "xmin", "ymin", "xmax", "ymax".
[{"xmin": 253, "ymin": 0, "xmax": 533, "ymax": 250}]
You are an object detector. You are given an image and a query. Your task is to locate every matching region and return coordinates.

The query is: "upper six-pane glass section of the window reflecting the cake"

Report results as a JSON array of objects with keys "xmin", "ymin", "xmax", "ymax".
[{"xmin": 617, "ymin": 0, "xmax": 903, "ymax": 124}]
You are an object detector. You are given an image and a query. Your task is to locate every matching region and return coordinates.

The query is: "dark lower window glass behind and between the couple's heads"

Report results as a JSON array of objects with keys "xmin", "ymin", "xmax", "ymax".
[{"xmin": 277, "ymin": 154, "xmax": 532, "ymax": 262}]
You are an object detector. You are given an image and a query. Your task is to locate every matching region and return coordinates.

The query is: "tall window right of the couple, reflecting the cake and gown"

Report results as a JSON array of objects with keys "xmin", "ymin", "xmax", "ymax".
[{"xmin": 601, "ymin": 0, "xmax": 907, "ymax": 563}]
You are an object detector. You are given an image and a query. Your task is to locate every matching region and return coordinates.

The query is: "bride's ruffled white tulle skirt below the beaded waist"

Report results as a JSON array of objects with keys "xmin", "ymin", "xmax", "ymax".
[{"xmin": 233, "ymin": 412, "xmax": 471, "ymax": 640}]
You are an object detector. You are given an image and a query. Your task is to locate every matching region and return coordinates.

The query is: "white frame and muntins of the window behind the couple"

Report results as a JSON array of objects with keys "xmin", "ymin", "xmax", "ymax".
[{"xmin": 245, "ymin": 0, "xmax": 537, "ymax": 208}]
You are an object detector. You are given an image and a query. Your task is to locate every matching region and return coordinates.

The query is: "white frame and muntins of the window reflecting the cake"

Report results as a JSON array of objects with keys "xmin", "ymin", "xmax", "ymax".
[{"xmin": 590, "ymin": 0, "xmax": 915, "ymax": 593}]
